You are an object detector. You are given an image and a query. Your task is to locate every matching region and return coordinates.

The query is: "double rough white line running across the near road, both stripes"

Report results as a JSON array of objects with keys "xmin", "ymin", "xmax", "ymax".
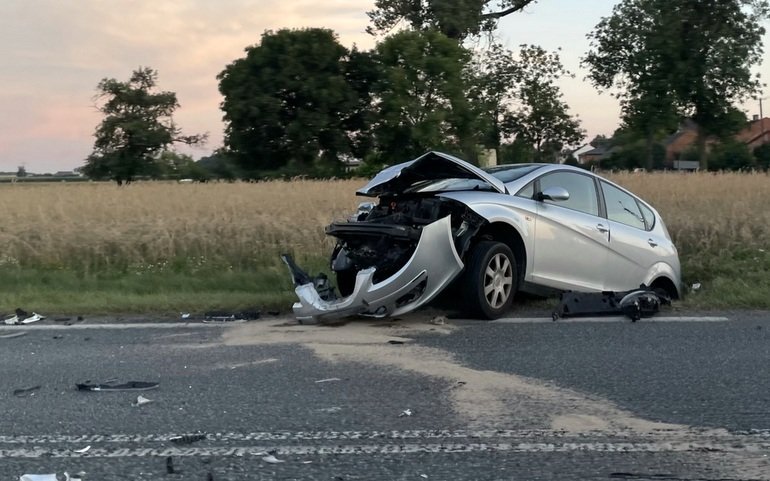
[{"xmin": 0, "ymin": 429, "xmax": 770, "ymax": 459}]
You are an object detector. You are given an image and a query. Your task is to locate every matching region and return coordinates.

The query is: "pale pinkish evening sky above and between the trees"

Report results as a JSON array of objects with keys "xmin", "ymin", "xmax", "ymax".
[{"xmin": 0, "ymin": 0, "xmax": 770, "ymax": 173}]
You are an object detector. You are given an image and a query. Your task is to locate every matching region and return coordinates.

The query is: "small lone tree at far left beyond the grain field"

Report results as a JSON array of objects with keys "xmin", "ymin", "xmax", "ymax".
[{"xmin": 83, "ymin": 67, "xmax": 206, "ymax": 185}]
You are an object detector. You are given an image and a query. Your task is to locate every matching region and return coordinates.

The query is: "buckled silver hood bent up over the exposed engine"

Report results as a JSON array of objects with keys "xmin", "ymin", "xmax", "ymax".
[{"xmin": 356, "ymin": 152, "xmax": 507, "ymax": 197}]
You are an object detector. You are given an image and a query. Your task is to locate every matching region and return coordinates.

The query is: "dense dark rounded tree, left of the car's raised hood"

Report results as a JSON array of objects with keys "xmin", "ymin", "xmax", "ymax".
[{"xmin": 217, "ymin": 28, "xmax": 366, "ymax": 173}]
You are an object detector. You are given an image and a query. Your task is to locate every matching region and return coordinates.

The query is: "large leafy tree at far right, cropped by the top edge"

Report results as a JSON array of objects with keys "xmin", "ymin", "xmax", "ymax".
[{"xmin": 584, "ymin": 0, "xmax": 768, "ymax": 169}]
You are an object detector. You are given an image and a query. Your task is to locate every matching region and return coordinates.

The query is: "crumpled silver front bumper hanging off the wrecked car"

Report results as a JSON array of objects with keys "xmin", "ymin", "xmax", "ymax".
[{"xmin": 289, "ymin": 216, "xmax": 463, "ymax": 323}]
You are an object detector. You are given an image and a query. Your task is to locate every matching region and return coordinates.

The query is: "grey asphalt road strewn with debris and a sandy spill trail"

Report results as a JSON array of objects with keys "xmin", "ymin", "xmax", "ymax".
[{"xmin": 0, "ymin": 313, "xmax": 770, "ymax": 481}]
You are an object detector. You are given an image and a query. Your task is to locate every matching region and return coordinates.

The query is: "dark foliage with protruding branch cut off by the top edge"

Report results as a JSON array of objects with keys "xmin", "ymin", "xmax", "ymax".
[{"xmin": 367, "ymin": 0, "xmax": 535, "ymax": 40}]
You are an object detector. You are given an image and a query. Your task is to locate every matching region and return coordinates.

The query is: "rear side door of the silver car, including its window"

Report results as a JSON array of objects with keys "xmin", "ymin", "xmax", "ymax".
[{"xmin": 599, "ymin": 181, "xmax": 664, "ymax": 291}]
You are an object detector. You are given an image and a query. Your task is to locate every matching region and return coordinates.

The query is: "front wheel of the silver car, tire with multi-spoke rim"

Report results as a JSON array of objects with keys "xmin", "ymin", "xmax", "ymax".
[{"xmin": 458, "ymin": 241, "xmax": 519, "ymax": 319}]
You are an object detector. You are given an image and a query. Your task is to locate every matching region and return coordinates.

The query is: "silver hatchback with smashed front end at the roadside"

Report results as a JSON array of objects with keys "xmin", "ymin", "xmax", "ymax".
[{"xmin": 284, "ymin": 152, "xmax": 680, "ymax": 322}]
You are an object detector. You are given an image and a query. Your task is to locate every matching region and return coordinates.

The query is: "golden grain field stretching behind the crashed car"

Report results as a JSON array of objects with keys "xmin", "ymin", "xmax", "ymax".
[{"xmin": 0, "ymin": 173, "xmax": 770, "ymax": 307}]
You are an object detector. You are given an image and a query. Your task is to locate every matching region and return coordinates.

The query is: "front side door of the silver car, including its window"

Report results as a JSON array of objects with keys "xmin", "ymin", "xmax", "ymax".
[{"xmin": 532, "ymin": 171, "xmax": 610, "ymax": 290}]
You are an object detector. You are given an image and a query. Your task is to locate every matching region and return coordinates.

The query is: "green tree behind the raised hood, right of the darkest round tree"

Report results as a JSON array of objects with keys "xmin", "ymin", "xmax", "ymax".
[{"xmin": 373, "ymin": 30, "xmax": 480, "ymax": 163}]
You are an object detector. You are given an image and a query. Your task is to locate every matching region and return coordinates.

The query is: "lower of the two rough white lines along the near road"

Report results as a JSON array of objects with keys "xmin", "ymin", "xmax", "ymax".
[{"xmin": 0, "ymin": 442, "xmax": 770, "ymax": 459}]
